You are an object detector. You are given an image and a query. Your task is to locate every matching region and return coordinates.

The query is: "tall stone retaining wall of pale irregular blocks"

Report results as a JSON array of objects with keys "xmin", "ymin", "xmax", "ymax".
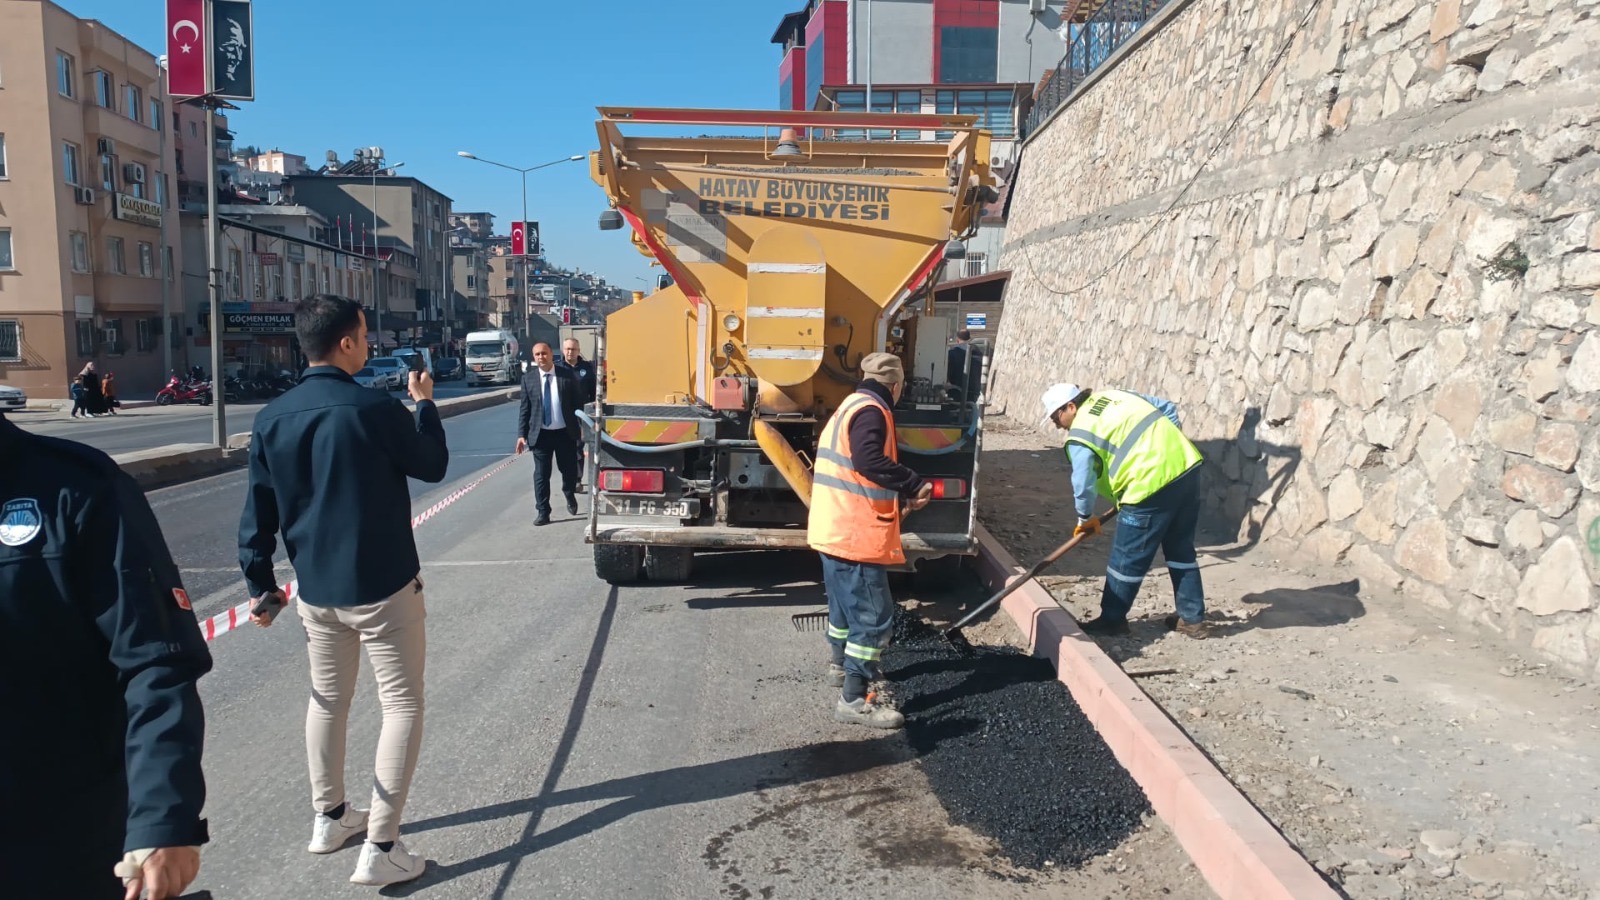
[{"xmin": 992, "ymin": 0, "xmax": 1600, "ymax": 677}]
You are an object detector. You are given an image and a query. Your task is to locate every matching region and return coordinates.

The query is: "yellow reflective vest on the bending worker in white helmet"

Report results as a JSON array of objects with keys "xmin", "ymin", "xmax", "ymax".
[{"xmin": 1067, "ymin": 391, "xmax": 1202, "ymax": 504}]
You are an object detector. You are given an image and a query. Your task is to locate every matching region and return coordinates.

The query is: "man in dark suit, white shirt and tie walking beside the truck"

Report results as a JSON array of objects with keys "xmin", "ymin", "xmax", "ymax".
[{"xmin": 517, "ymin": 341, "xmax": 582, "ymax": 525}]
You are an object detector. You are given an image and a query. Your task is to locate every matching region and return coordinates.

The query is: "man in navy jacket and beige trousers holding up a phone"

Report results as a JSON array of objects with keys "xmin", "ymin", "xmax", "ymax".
[{"xmin": 238, "ymin": 295, "xmax": 450, "ymax": 884}]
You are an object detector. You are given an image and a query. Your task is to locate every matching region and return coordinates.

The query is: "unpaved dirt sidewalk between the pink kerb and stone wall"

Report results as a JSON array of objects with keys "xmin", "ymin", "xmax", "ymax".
[{"xmin": 978, "ymin": 418, "xmax": 1600, "ymax": 900}]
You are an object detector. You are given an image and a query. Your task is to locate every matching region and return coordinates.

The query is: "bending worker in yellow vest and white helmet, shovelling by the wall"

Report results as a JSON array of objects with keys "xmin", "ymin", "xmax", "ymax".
[{"xmin": 1043, "ymin": 384, "xmax": 1206, "ymax": 637}]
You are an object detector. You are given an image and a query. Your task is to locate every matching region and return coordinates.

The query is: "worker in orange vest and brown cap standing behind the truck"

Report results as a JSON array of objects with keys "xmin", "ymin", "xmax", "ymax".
[{"xmin": 806, "ymin": 352, "xmax": 933, "ymax": 729}]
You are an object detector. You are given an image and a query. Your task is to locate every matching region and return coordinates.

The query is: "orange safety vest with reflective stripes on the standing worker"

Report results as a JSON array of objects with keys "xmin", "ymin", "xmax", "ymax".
[{"xmin": 806, "ymin": 391, "xmax": 906, "ymax": 565}]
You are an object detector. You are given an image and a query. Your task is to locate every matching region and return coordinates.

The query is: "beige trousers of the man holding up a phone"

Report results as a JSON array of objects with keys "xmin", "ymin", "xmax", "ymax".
[{"xmin": 298, "ymin": 578, "xmax": 427, "ymax": 841}]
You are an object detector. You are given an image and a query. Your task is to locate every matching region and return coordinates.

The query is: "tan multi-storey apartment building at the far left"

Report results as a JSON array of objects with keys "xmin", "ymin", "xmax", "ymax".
[{"xmin": 0, "ymin": 0, "xmax": 182, "ymax": 399}]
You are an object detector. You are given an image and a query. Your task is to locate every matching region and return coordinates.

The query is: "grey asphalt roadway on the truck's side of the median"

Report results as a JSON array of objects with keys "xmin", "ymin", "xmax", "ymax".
[{"xmin": 128, "ymin": 398, "xmax": 1113, "ymax": 900}]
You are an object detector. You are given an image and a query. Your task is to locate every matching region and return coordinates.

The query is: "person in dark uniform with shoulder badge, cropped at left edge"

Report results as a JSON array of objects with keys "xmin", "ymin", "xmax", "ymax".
[{"xmin": 0, "ymin": 415, "xmax": 211, "ymax": 900}]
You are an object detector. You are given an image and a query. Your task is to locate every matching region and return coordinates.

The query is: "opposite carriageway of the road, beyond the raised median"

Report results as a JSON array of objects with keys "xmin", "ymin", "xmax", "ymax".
[{"xmin": 6, "ymin": 381, "xmax": 492, "ymax": 456}]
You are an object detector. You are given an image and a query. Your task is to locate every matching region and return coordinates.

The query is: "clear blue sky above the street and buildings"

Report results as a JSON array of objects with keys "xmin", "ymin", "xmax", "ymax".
[{"xmin": 65, "ymin": 0, "xmax": 790, "ymax": 288}]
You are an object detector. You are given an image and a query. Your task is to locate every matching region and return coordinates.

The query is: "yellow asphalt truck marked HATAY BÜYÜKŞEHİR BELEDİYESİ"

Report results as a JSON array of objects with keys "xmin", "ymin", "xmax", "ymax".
[{"xmin": 581, "ymin": 107, "xmax": 997, "ymax": 583}]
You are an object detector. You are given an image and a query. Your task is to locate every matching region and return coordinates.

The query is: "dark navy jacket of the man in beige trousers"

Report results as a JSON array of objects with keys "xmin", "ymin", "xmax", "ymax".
[{"xmin": 238, "ymin": 365, "xmax": 450, "ymax": 607}]
